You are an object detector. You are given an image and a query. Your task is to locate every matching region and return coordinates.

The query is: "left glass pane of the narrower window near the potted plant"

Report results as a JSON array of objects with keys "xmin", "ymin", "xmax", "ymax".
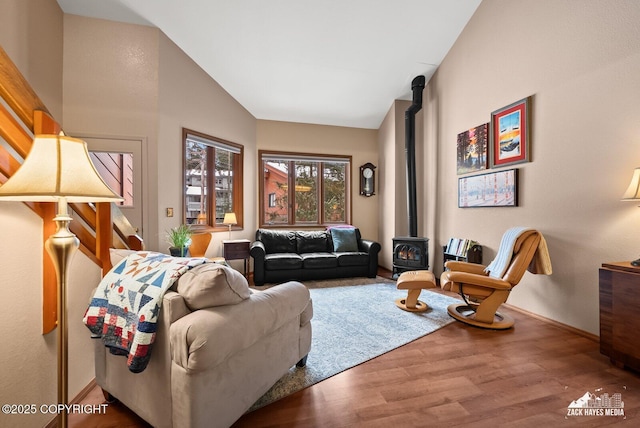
[{"xmin": 185, "ymin": 141, "xmax": 209, "ymax": 224}]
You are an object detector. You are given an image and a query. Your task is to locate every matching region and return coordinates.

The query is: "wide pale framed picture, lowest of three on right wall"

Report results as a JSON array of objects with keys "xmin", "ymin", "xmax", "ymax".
[{"xmin": 458, "ymin": 169, "xmax": 518, "ymax": 208}]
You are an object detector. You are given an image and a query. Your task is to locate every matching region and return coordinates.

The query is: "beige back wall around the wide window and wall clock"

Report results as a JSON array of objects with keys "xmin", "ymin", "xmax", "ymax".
[{"xmin": 254, "ymin": 120, "xmax": 382, "ymax": 240}]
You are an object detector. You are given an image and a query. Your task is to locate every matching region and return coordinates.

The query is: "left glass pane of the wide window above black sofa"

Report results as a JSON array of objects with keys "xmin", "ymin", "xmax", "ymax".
[{"xmin": 262, "ymin": 161, "xmax": 289, "ymax": 224}]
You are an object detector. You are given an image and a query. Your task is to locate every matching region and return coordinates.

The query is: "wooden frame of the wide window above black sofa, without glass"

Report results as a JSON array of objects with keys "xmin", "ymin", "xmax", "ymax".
[{"xmin": 258, "ymin": 150, "xmax": 353, "ymax": 229}]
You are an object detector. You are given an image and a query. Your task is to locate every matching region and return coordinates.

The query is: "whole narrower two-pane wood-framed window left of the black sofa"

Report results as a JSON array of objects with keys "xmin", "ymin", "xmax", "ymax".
[{"xmin": 183, "ymin": 129, "xmax": 243, "ymax": 230}]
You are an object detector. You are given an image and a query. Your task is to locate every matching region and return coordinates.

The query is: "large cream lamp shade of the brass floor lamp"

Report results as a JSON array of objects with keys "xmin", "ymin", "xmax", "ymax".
[{"xmin": 0, "ymin": 135, "xmax": 123, "ymax": 202}]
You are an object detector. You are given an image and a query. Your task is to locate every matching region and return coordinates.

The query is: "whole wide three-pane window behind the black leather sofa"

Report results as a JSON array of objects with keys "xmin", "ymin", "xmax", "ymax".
[{"xmin": 259, "ymin": 151, "xmax": 351, "ymax": 226}]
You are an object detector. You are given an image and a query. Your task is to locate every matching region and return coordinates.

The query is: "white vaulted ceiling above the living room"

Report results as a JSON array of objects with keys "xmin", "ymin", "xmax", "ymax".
[{"xmin": 57, "ymin": 0, "xmax": 481, "ymax": 129}]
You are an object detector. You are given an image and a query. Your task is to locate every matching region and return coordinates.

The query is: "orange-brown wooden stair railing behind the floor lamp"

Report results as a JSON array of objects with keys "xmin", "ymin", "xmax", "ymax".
[{"xmin": 0, "ymin": 46, "xmax": 143, "ymax": 334}]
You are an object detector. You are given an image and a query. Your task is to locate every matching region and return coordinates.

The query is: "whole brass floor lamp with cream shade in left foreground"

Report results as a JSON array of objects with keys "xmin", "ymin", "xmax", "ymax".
[{"xmin": 0, "ymin": 135, "xmax": 122, "ymax": 427}]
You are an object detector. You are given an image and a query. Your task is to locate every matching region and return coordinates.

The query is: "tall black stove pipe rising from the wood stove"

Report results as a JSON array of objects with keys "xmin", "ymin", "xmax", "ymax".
[{"xmin": 404, "ymin": 76, "xmax": 425, "ymax": 237}]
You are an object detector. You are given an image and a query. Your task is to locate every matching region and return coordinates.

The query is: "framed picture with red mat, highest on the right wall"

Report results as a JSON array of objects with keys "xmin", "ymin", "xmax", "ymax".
[{"xmin": 489, "ymin": 97, "xmax": 531, "ymax": 168}]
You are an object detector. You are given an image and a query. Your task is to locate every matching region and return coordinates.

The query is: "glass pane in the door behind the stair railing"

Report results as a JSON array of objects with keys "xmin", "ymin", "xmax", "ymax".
[{"xmin": 89, "ymin": 152, "xmax": 133, "ymax": 207}]
